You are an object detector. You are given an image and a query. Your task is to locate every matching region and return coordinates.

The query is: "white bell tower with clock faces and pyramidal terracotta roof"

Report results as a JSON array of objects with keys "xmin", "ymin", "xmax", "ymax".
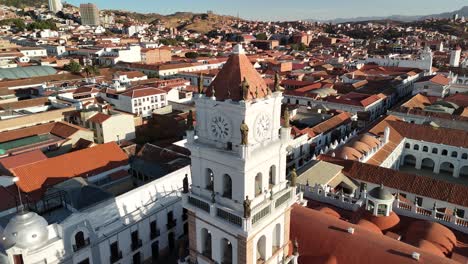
[{"xmin": 183, "ymin": 46, "xmax": 297, "ymax": 264}]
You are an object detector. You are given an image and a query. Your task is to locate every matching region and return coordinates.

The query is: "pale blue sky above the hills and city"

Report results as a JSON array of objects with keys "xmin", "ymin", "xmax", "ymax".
[{"xmin": 66, "ymin": 0, "xmax": 468, "ymax": 21}]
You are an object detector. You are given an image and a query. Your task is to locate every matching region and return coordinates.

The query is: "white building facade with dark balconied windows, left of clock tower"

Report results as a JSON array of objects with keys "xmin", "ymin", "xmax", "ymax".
[{"xmin": 6, "ymin": 167, "xmax": 190, "ymax": 264}]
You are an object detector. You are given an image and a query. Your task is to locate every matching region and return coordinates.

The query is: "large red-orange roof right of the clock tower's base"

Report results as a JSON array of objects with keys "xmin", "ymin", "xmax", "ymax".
[{"xmin": 290, "ymin": 205, "xmax": 456, "ymax": 264}]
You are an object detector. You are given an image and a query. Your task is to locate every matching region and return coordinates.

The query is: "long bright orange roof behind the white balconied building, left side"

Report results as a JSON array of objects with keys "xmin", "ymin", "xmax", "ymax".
[{"xmin": 12, "ymin": 142, "xmax": 128, "ymax": 194}]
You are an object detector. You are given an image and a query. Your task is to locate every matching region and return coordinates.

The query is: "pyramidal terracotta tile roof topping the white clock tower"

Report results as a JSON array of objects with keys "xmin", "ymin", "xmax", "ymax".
[{"xmin": 206, "ymin": 51, "xmax": 268, "ymax": 101}]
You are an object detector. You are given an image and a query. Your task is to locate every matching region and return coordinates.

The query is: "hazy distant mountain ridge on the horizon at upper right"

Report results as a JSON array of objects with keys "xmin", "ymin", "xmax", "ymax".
[{"xmin": 310, "ymin": 6, "xmax": 468, "ymax": 24}]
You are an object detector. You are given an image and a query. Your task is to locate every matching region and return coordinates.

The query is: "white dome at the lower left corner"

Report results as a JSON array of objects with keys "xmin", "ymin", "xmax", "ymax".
[{"xmin": 2, "ymin": 211, "xmax": 49, "ymax": 249}]
